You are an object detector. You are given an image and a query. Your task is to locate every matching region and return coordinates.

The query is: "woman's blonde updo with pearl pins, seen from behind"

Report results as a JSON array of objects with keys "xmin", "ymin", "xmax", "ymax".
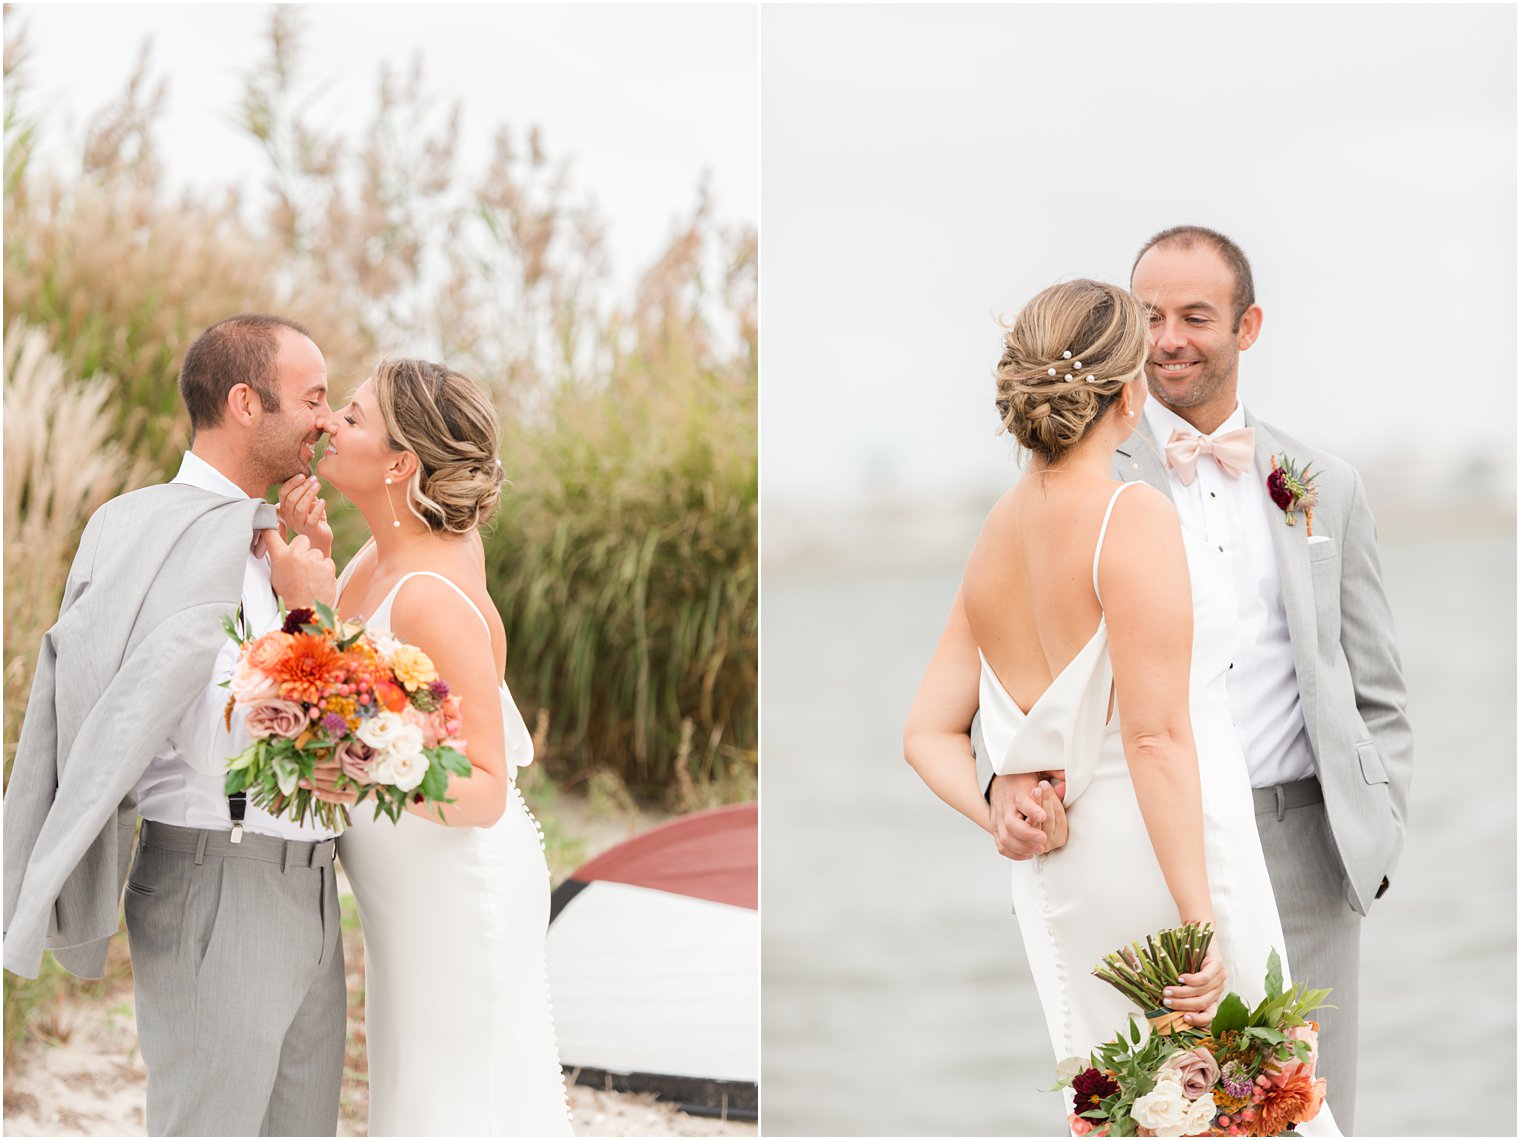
[{"xmin": 994, "ymin": 280, "xmax": 1149, "ymax": 464}]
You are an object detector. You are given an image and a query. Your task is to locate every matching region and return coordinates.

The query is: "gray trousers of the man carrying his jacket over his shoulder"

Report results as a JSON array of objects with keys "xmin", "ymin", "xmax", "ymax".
[{"xmin": 126, "ymin": 821, "xmax": 347, "ymax": 1135}]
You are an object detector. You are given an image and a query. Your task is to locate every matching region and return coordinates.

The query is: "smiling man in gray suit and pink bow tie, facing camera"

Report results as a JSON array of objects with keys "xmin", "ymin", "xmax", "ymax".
[{"xmin": 973, "ymin": 226, "xmax": 1414, "ymax": 1132}]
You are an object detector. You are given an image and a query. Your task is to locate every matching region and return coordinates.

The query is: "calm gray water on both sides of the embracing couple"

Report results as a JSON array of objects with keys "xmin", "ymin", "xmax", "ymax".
[{"xmin": 762, "ymin": 534, "xmax": 1515, "ymax": 1135}]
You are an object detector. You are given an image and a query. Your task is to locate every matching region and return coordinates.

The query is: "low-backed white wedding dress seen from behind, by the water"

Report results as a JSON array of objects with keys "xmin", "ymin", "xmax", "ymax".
[{"xmin": 980, "ymin": 483, "xmax": 1339, "ymax": 1135}]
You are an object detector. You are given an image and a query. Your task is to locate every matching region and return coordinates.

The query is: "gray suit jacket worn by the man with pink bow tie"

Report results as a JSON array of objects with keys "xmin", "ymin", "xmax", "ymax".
[{"xmin": 971, "ymin": 410, "xmax": 1414, "ymax": 914}]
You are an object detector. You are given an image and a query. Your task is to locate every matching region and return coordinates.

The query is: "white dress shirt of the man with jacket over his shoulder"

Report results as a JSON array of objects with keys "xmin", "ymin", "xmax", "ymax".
[{"xmin": 137, "ymin": 451, "xmax": 333, "ymax": 841}]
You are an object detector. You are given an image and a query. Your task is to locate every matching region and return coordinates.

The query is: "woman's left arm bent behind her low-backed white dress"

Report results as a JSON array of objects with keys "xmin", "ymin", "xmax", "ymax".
[{"xmin": 903, "ymin": 591, "xmax": 1059, "ymax": 857}]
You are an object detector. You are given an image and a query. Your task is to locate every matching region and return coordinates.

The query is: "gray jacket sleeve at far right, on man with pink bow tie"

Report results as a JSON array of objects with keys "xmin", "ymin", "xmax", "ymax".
[{"xmin": 1341, "ymin": 474, "xmax": 1414, "ymax": 869}]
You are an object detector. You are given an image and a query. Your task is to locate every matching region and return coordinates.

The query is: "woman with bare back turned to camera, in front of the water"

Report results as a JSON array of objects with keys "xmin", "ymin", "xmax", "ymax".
[{"xmin": 904, "ymin": 280, "xmax": 1336, "ymax": 1135}]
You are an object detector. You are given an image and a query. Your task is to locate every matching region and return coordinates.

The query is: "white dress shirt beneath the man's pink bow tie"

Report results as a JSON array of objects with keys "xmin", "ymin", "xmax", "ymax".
[{"xmin": 1145, "ymin": 398, "xmax": 1315, "ymax": 787}]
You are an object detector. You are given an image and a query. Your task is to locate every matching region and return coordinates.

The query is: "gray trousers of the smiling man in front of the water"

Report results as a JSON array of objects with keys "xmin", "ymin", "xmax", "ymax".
[{"xmin": 1256, "ymin": 777, "xmax": 1362, "ymax": 1135}]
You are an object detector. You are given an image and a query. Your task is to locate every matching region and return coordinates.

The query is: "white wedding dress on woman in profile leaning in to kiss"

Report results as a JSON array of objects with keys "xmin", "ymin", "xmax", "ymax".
[{"xmin": 337, "ymin": 565, "xmax": 572, "ymax": 1135}]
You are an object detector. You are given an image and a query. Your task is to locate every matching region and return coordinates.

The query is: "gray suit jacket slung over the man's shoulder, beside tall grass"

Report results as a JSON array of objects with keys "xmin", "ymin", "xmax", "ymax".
[{"xmin": 5, "ymin": 483, "xmax": 274, "ymax": 977}]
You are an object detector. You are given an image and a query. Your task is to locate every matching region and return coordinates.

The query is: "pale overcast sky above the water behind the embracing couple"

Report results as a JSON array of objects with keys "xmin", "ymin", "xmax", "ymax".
[{"xmin": 762, "ymin": 5, "xmax": 1515, "ymax": 506}]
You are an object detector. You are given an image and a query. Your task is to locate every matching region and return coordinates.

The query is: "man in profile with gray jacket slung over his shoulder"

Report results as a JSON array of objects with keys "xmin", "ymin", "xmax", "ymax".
[{"xmin": 5, "ymin": 313, "xmax": 347, "ymax": 1135}]
